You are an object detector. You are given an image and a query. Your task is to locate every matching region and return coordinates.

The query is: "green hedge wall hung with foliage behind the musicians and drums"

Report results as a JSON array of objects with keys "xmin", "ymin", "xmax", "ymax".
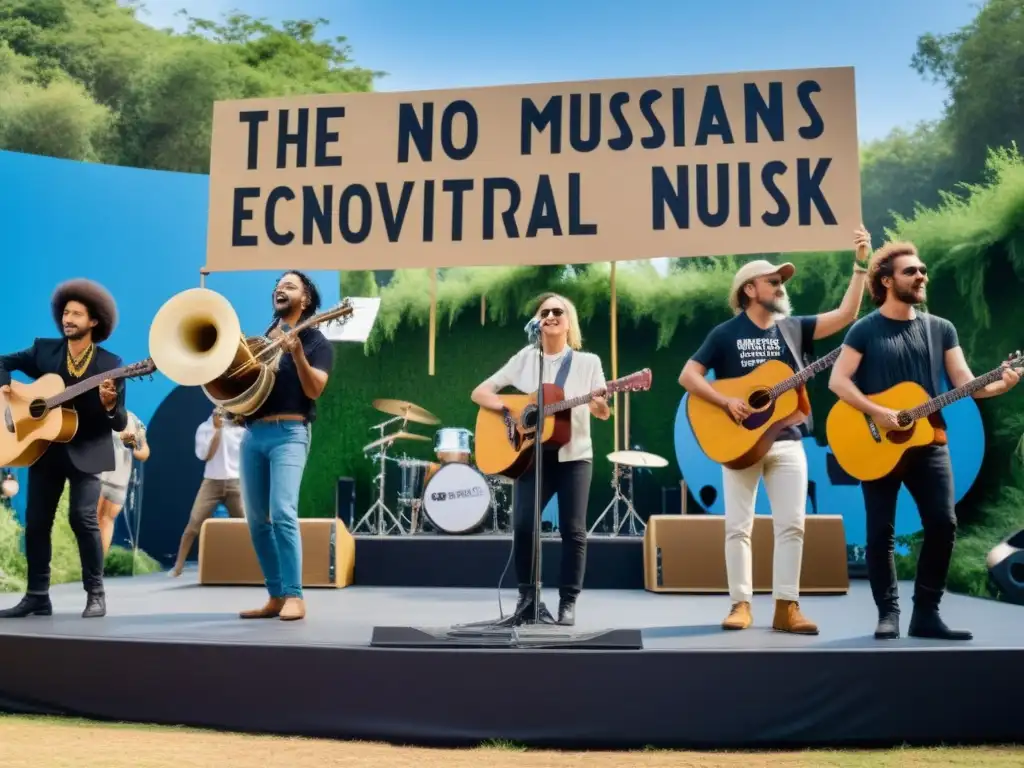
[{"xmin": 301, "ymin": 147, "xmax": 1024, "ymax": 594}]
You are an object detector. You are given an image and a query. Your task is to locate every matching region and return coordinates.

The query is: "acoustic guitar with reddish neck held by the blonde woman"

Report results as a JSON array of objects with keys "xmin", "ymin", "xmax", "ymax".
[{"xmin": 474, "ymin": 368, "xmax": 651, "ymax": 480}]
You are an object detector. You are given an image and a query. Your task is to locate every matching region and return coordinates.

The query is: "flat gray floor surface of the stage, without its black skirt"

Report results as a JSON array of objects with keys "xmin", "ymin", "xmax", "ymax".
[{"xmin": 0, "ymin": 570, "xmax": 1024, "ymax": 651}]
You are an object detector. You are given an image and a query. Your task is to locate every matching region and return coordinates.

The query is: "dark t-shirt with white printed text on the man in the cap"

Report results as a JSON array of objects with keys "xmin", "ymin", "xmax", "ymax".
[{"xmin": 692, "ymin": 312, "xmax": 818, "ymax": 440}]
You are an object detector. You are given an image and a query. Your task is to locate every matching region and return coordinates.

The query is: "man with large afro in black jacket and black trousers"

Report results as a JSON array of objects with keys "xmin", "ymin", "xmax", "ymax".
[{"xmin": 0, "ymin": 279, "xmax": 128, "ymax": 618}]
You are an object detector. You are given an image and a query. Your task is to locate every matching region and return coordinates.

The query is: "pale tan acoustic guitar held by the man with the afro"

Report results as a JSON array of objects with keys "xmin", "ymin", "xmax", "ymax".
[{"xmin": 0, "ymin": 357, "xmax": 157, "ymax": 467}]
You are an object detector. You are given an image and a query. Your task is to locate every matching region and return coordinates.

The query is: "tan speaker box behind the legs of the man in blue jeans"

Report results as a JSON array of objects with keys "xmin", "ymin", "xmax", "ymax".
[{"xmin": 199, "ymin": 517, "xmax": 355, "ymax": 588}]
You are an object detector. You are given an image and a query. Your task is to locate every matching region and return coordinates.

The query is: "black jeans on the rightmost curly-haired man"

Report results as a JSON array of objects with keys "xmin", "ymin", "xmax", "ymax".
[{"xmin": 861, "ymin": 445, "xmax": 956, "ymax": 612}]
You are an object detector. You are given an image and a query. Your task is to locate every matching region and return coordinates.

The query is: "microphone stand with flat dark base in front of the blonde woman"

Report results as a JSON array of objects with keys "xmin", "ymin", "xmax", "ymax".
[{"xmin": 370, "ymin": 325, "xmax": 643, "ymax": 650}]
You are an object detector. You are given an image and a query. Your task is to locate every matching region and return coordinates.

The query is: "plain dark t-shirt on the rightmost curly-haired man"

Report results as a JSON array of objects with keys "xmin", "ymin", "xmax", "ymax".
[{"xmin": 843, "ymin": 309, "xmax": 959, "ymax": 397}]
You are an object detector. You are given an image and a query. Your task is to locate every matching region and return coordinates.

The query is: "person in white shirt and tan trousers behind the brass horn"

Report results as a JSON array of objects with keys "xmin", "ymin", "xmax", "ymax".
[{"xmin": 170, "ymin": 409, "xmax": 246, "ymax": 577}]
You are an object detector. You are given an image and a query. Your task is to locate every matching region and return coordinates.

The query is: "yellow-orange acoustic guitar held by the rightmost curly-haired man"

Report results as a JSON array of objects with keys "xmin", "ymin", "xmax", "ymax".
[{"xmin": 825, "ymin": 355, "xmax": 1024, "ymax": 481}]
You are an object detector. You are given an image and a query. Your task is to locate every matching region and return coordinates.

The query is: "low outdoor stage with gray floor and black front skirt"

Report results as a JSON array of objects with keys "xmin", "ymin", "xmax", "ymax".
[{"xmin": 0, "ymin": 570, "xmax": 1024, "ymax": 749}]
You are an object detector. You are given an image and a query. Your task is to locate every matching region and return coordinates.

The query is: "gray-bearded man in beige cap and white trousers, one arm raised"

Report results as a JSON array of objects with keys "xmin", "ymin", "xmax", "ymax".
[{"xmin": 679, "ymin": 227, "xmax": 871, "ymax": 635}]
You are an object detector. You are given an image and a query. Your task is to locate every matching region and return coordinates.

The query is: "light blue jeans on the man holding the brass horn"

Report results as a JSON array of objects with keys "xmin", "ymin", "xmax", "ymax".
[{"xmin": 239, "ymin": 421, "xmax": 309, "ymax": 597}]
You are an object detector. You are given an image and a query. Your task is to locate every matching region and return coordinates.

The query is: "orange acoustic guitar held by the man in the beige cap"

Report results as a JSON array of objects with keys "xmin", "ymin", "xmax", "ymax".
[{"xmin": 686, "ymin": 347, "xmax": 842, "ymax": 469}]
